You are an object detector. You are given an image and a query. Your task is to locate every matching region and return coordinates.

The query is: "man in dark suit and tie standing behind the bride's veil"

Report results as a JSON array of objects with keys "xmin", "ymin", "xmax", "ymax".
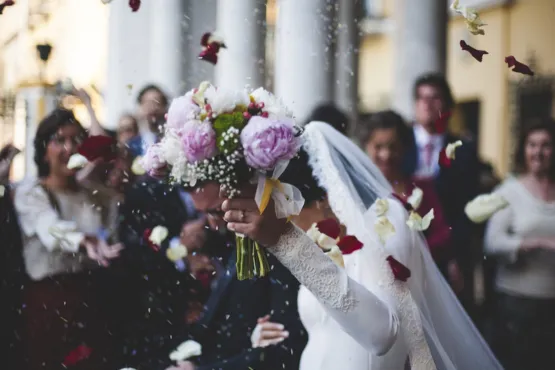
[{"xmin": 406, "ymin": 74, "xmax": 479, "ymax": 310}]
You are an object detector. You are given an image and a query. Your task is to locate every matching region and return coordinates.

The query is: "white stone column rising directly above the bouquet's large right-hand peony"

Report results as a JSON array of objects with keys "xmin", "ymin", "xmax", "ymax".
[{"xmin": 275, "ymin": 0, "xmax": 334, "ymax": 123}]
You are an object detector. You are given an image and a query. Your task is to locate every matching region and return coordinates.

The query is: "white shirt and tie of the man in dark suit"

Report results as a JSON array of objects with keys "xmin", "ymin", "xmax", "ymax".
[{"xmin": 413, "ymin": 123, "xmax": 445, "ymax": 178}]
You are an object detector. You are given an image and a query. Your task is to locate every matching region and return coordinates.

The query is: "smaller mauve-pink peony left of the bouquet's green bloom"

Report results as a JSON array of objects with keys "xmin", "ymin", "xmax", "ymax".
[{"xmin": 179, "ymin": 121, "xmax": 217, "ymax": 163}]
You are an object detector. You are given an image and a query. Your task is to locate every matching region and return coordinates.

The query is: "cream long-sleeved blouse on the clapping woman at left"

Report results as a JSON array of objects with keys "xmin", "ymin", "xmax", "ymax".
[{"xmin": 14, "ymin": 179, "xmax": 115, "ymax": 280}]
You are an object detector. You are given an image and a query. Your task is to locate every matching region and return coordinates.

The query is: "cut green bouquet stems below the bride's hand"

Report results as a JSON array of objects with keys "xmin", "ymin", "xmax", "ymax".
[{"xmin": 235, "ymin": 234, "xmax": 270, "ymax": 280}]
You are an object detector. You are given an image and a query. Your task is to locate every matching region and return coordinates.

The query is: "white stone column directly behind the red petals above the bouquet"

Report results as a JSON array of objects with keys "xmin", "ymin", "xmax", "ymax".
[{"xmin": 216, "ymin": 0, "xmax": 266, "ymax": 89}]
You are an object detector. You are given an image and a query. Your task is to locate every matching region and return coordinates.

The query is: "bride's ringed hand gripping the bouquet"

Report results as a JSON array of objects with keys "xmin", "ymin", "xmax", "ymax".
[{"xmin": 222, "ymin": 189, "xmax": 289, "ymax": 247}]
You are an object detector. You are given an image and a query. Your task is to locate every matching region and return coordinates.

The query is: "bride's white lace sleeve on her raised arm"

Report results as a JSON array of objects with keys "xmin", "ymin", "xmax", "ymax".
[{"xmin": 269, "ymin": 225, "xmax": 399, "ymax": 355}]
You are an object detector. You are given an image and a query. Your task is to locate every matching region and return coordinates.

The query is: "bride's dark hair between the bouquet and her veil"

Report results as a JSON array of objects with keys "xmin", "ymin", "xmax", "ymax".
[{"xmin": 279, "ymin": 149, "xmax": 327, "ymax": 206}]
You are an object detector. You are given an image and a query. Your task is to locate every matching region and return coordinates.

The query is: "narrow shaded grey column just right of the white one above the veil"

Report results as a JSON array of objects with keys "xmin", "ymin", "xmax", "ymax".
[{"xmin": 335, "ymin": 0, "xmax": 362, "ymax": 131}]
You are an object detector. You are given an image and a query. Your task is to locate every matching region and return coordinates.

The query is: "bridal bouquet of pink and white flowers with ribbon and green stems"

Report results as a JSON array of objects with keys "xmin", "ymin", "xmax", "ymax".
[{"xmin": 142, "ymin": 82, "xmax": 304, "ymax": 280}]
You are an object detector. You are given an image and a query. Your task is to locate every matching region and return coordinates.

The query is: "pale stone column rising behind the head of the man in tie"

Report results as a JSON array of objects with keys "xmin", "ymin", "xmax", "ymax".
[{"xmin": 392, "ymin": 0, "xmax": 448, "ymax": 119}]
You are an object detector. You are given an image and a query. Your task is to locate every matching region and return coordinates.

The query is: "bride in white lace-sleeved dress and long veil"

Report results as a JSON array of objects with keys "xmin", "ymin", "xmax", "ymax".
[{"xmin": 222, "ymin": 122, "xmax": 502, "ymax": 370}]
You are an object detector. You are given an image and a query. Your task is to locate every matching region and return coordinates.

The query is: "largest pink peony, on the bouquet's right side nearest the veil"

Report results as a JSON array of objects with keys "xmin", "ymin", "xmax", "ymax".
[{"xmin": 241, "ymin": 116, "xmax": 301, "ymax": 171}]
